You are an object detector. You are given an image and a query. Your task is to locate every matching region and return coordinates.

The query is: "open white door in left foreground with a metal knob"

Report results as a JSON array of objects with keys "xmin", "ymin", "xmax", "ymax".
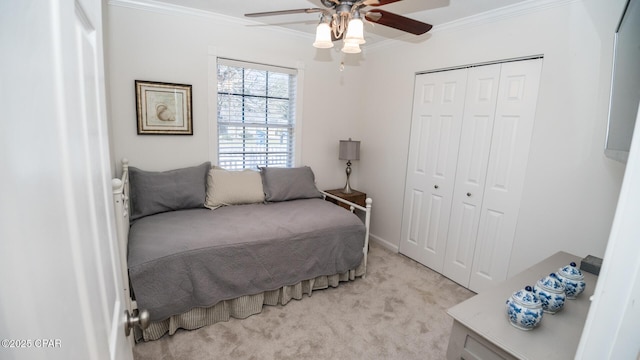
[{"xmin": 0, "ymin": 0, "xmax": 133, "ymax": 360}]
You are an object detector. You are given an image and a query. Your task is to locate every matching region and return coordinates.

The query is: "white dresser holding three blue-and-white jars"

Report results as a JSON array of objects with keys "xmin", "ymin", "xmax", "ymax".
[{"xmin": 447, "ymin": 252, "xmax": 598, "ymax": 360}]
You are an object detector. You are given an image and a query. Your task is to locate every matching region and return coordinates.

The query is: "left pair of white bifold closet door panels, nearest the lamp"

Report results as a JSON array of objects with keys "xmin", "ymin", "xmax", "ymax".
[{"xmin": 400, "ymin": 69, "xmax": 467, "ymax": 272}]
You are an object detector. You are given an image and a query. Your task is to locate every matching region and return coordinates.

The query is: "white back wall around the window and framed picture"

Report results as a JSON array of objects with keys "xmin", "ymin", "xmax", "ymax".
[{"xmin": 106, "ymin": 1, "xmax": 363, "ymax": 189}]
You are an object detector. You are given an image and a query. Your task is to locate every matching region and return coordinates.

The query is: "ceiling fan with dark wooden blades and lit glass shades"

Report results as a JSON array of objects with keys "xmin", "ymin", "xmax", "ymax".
[{"xmin": 245, "ymin": 0, "xmax": 433, "ymax": 53}]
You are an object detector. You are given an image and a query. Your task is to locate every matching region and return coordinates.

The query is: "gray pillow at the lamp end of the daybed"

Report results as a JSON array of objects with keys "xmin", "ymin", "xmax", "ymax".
[{"xmin": 260, "ymin": 166, "xmax": 322, "ymax": 202}]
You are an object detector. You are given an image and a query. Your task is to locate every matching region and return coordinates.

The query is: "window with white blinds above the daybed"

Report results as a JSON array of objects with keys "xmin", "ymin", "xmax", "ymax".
[{"xmin": 217, "ymin": 58, "xmax": 296, "ymax": 170}]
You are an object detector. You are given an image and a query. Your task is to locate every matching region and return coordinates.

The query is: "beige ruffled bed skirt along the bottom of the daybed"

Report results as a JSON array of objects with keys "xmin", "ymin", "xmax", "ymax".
[{"xmin": 136, "ymin": 262, "xmax": 365, "ymax": 342}]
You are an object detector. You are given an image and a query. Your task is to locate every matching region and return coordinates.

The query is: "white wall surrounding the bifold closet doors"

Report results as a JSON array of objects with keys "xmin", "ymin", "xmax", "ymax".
[{"xmin": 360, "ymin": 0, "xmax": 624, "ymax": 275}]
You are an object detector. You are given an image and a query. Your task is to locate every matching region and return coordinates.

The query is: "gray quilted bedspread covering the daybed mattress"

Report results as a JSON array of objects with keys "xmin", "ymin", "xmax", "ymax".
[{"xmin": 128, "ymin": 199, "xmax": 365, "ymax": 321}]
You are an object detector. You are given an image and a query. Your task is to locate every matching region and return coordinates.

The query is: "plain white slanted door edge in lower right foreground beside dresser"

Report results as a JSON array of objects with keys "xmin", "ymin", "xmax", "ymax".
[{"xmin": 575, "ymin": 100, "xmax": 640, "ymax": 359}]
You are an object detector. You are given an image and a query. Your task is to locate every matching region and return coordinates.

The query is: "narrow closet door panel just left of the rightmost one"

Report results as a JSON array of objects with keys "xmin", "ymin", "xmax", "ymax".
[{"xmin": 442, "ymin": 64, "xmax": 501, "ymax": 286}]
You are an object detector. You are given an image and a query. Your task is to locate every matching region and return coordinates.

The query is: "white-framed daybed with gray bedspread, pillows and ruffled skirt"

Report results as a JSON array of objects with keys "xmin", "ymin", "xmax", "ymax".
[{"xmin": 113, "ymin": 160, "xmax": 371, "ymax": 340}]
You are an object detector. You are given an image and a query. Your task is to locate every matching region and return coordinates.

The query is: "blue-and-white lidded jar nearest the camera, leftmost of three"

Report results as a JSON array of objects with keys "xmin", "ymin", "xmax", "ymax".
[{"xmin": 507, "ymin": 286, "xmax": 544, "ymax": 330}]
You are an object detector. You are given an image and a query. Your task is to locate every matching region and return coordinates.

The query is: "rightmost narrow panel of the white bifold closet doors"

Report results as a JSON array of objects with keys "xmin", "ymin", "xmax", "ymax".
[{"xmin": 469, "ymin": 59, "xmax": 542, "ymax": 292}]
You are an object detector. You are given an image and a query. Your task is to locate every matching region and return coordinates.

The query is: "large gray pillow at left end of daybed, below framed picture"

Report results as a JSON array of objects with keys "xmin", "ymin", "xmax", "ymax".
[{"xmin": 129, "ymin": 162, "xmax": 211, "ymax": 221}]
